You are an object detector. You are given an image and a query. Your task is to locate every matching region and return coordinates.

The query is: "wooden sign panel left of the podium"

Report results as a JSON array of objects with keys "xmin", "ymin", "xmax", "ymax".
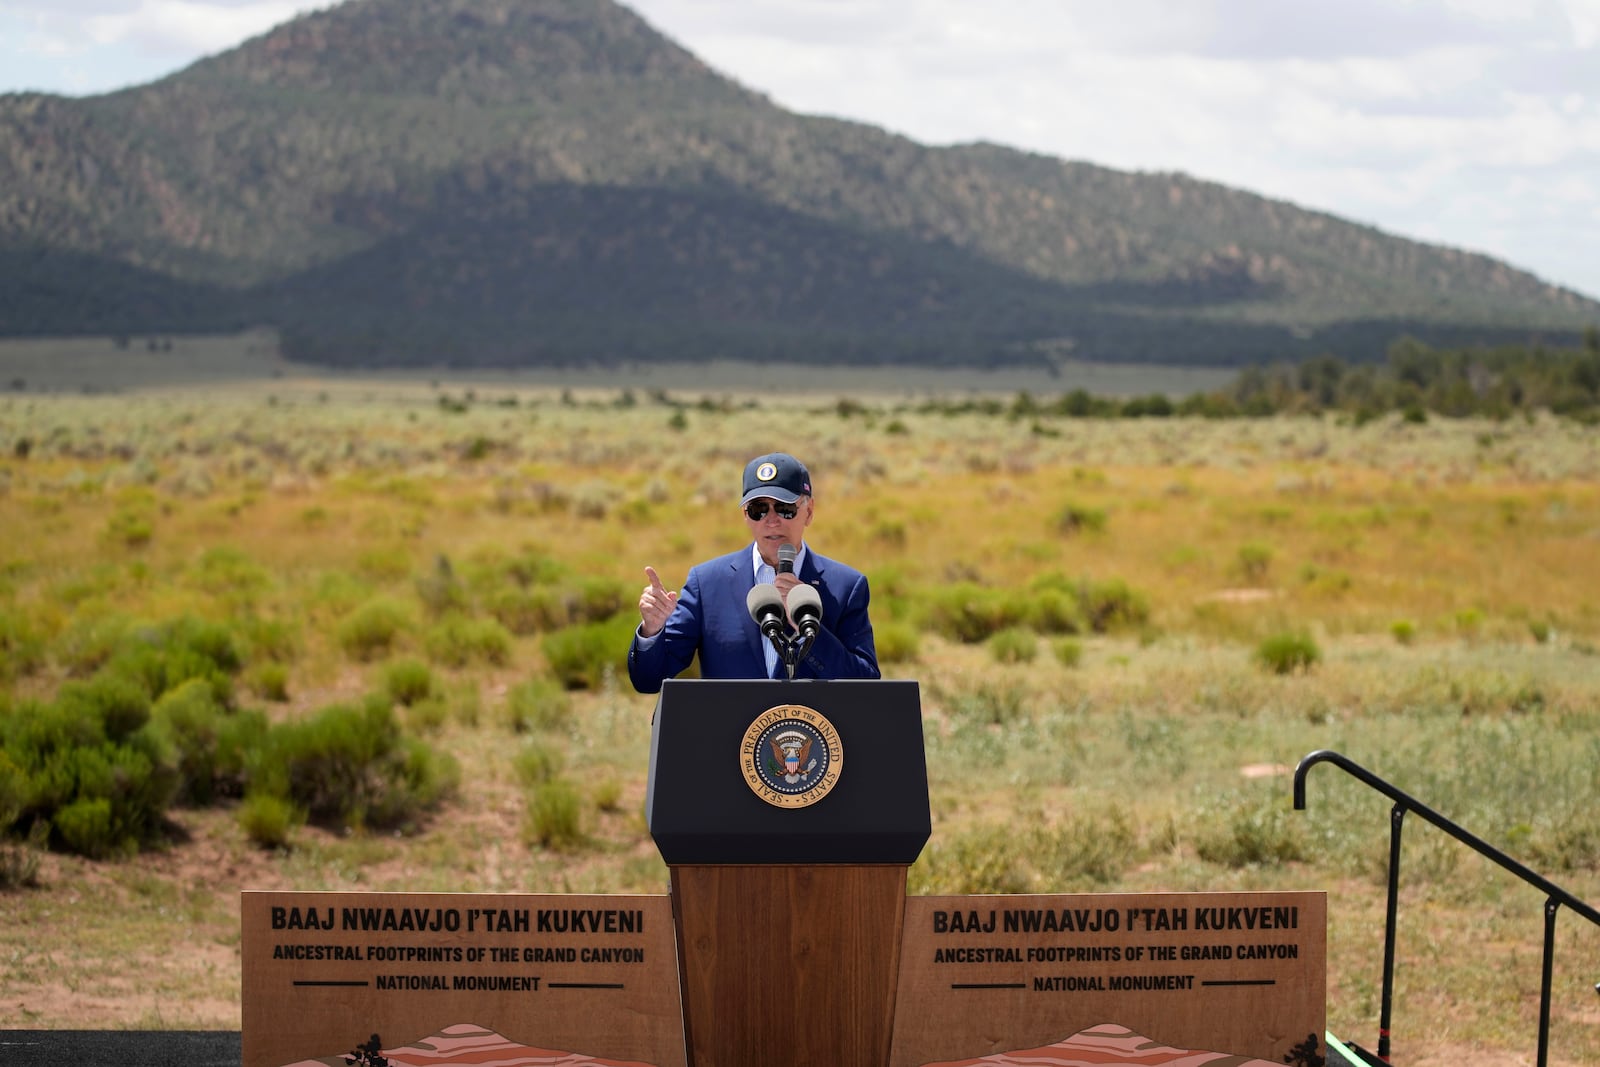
[{"xmin": 240, "ymin": 891, "xmax": 686, "ymax": 1067}]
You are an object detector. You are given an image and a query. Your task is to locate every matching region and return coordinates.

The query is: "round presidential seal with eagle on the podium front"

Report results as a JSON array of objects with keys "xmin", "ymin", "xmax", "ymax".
[{"xmin": 739, "ymin": 704, "xmax": 845, "ymax": 808}]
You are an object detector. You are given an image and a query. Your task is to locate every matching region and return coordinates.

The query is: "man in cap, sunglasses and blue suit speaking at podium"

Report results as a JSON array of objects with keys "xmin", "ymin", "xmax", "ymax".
[{"xmin": 627, "ymin": 453, "xmax": 880, "ymax": 693}]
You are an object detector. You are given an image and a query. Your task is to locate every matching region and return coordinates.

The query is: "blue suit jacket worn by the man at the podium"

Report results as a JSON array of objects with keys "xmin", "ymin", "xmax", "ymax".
[{"xmin": 627, "ymin": 545, "xmax": 880, "ymax": 693}]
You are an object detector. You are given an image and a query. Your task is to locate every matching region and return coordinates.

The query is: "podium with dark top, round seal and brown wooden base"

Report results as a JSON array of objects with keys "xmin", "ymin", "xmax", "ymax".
[{"xmin": 645, "ymin": 680, "xmax": 933, "ymax": 1067}]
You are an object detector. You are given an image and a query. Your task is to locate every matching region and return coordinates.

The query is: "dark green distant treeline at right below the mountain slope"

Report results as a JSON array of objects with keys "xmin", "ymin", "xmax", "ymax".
[{"xmin": 934, "ymin": 326, "xmax": 1600, "ymax": 422}]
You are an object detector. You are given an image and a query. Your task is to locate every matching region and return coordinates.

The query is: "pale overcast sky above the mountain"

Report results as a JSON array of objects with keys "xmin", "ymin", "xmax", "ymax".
[{"xmin": 0, "ymin": 0, "xmax": 1600, "ymax": 298}]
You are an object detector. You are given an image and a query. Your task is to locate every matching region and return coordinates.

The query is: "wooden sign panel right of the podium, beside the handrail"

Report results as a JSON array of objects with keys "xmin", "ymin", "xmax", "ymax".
[{"xmin": 890, "ymin": 893, "xmax": 1328, "ymax": 1067}]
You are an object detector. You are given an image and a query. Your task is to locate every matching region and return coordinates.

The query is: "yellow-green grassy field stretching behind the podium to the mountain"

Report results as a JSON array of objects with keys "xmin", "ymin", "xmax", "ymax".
[{"xmin": 0, "ymin": 374, "xmax": 1600, "ymax": 1064}]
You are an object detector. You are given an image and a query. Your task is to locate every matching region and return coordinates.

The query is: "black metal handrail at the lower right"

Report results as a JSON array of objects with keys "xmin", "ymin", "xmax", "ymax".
[{"xmin": 1294, "ymin": 749, "xmax": 1600, "ymax": 1067}]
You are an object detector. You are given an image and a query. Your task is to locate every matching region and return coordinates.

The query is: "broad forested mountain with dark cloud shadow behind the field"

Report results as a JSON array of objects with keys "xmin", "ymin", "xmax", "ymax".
[{"xmin": 0, "ymin": 0, "xmax": 1600, "ymax": 365}]
